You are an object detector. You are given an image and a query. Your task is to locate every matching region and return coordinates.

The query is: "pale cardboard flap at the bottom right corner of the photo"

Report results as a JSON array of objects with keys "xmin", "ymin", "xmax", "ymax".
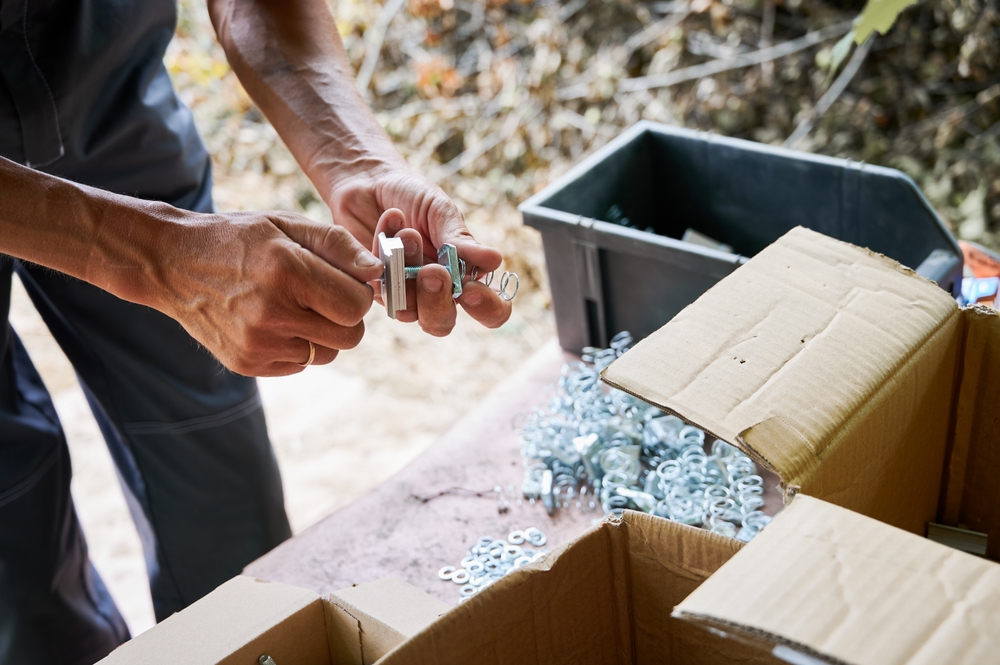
[{"xmin": 673, "ymin": 495, "xmax": 1000, "ymax": 665}]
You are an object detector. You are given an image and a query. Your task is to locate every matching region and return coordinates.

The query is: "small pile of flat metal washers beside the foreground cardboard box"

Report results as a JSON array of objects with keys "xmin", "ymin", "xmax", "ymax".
[{"xmin": 438, "ymin": 527, "xmax": 548, "ymax": 602}]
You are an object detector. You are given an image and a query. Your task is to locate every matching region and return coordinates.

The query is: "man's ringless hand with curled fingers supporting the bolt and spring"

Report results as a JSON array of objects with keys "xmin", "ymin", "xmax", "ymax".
[{"xmin": 329, "ymin": 166, "xmax": 511, "ymax": 337}]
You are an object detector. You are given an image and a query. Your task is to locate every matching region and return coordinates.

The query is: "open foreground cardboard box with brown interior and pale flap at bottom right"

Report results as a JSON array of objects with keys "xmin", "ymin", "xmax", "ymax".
[{"xmin": 376, "ymin": 494, "xmax": 1000, "ymax": 665}]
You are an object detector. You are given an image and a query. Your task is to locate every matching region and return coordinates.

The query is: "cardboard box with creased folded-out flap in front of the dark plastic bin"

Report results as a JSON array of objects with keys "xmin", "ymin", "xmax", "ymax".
[{"xmin": 603, "ymin": 228, "xmax": 1000, "ymax": 559}]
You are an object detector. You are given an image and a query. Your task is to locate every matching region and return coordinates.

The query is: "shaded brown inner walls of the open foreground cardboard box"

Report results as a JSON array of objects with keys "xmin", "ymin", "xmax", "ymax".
[{"xmin": 379, "ymin": 512, "xmax": 778, "ymax": 665}]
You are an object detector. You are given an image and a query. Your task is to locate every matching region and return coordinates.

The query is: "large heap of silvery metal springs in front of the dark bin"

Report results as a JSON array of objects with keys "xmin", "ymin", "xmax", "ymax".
[{"xmin": 521, "ymin": 332, "xmax": 771, "ymax": 541}]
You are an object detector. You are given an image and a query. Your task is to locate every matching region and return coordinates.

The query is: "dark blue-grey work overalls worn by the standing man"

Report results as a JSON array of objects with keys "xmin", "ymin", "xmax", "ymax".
[{"xmin": 0, "ymin": 0, "xmax": 290, "ymax": 665}]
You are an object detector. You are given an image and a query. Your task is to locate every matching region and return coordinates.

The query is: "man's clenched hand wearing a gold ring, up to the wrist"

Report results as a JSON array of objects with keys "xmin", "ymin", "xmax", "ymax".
[{"xmin": 155, "ymin": 212, "xmax": 382, "ymax": 376}]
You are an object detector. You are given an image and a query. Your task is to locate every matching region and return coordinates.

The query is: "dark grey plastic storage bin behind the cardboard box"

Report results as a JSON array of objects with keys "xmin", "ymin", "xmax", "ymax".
[{"xmin": 520, "ymin": 122, "xmax": 962, "ymax": 352}]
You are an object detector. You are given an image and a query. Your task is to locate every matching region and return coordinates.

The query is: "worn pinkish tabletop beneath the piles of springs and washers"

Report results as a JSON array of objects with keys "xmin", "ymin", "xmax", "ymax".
[{"xmin": 244, "ymin": 339, "xmax": 781, "ymax": 605}]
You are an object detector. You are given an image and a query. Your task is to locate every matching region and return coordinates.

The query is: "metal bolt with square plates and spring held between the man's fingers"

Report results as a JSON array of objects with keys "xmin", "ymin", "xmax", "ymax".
[{"xmin": 378, "ymin": 233, "xmax": 520, "ymax": 319}]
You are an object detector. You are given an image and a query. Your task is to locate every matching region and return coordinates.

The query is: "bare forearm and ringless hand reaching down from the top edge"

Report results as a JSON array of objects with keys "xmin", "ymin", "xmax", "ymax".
[{"xmin": 208, "ymin": 0, "xmax": 510, "ymax": 335}]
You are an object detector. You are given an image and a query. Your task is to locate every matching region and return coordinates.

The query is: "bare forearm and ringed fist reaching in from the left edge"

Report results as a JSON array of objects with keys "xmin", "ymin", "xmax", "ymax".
[{"xmin": 0, "ymin": 158, "xmax": 381, "ymax": 375}]
